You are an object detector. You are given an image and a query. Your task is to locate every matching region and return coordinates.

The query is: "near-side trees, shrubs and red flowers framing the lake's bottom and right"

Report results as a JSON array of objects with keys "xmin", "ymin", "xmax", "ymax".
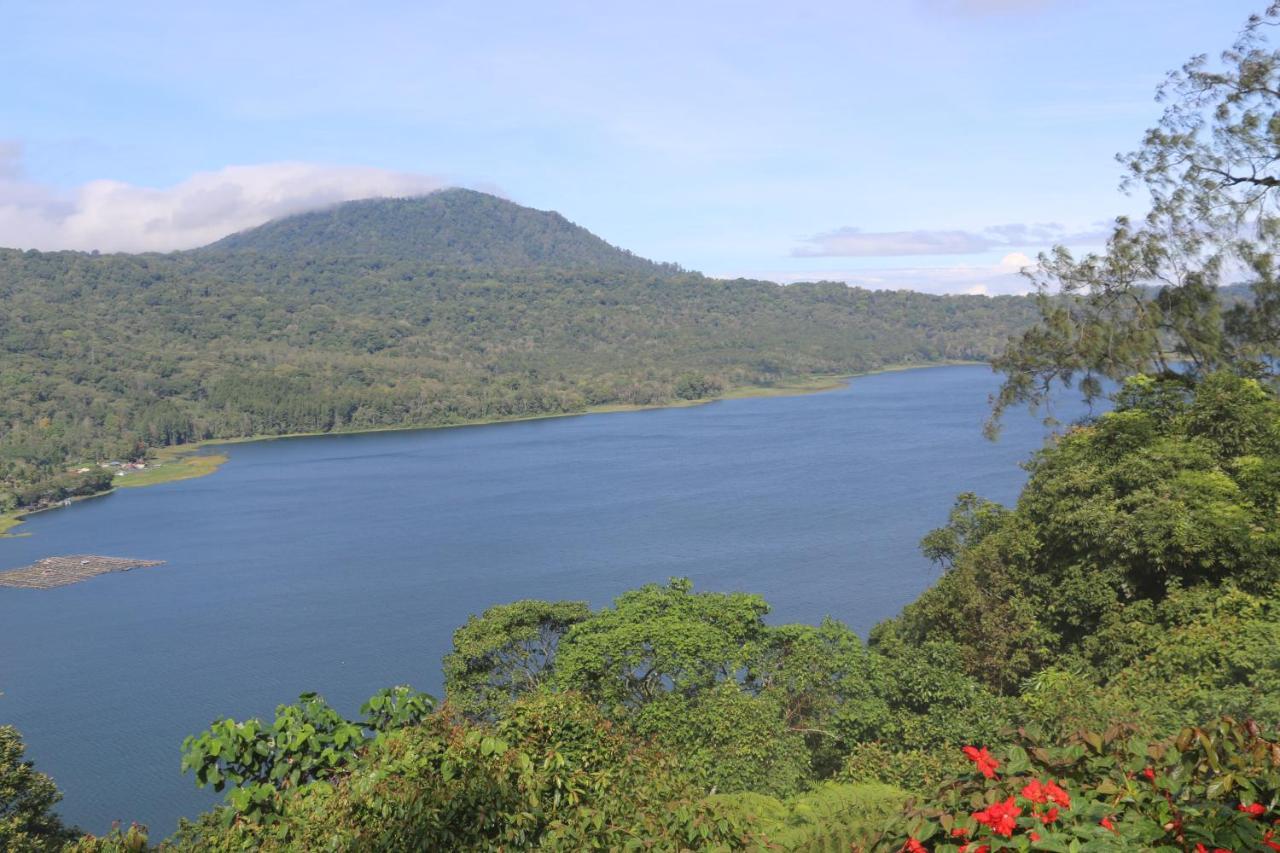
[{"xmin": 12, "ymin": 4, "xmax": 1280, "ymax": 853}]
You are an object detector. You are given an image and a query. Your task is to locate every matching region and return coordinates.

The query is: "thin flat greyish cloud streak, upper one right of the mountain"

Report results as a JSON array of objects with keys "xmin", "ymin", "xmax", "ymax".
[{"xmin": 791, "ymin": 222, "xmax": 1110, "ymax": 257}]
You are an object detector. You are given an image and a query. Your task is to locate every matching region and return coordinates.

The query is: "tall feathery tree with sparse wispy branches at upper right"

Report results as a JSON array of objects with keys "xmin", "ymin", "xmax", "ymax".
[{"xmin": 988, "ymin": 3, "xmax": 1280, "ymax": 433}]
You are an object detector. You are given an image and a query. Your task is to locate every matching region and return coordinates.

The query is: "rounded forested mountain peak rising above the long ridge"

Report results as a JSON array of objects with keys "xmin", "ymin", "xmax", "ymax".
[{"xmin": 197, "ymin": 188, "xmax": 677, "ymax": 274}]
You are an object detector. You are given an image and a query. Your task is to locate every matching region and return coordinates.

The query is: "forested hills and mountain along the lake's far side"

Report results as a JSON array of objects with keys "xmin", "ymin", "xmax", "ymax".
[{"xmin": 0, "ymin": 190, "xmax": 1034, "ymax": 511}]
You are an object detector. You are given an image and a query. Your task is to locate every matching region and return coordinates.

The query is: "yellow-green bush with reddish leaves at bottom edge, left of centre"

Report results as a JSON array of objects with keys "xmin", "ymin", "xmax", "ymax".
[{"xmin": 165, "ymin": 694, "xmax": 750, "ymax": 850}]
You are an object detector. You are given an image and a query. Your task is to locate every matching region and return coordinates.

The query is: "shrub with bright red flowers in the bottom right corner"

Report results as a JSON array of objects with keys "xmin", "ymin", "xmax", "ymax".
[{"xmin": 870, "ymin": 719, "xmax": 1280, "ymax": 853}]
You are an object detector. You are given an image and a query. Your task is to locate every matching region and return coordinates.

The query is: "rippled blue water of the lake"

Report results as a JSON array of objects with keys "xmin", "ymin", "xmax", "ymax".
[{"xmin": 0, "ymin": 366, "xmax": 1083, "ymax": 838}]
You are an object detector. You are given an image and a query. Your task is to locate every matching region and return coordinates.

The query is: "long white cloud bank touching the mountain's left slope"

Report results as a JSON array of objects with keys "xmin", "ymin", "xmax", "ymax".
[{"xmin": 0, "ymin": 142, "xmax": 447, "ymax": 252}]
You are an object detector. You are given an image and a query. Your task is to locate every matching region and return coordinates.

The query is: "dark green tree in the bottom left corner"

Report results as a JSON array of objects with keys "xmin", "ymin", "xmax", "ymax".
[{"xmin": 0, "ymin": 726, "xmax": 76, "ymax": 850}]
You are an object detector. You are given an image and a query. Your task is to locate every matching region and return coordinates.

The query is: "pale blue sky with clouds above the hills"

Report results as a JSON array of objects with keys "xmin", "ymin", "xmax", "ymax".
[{"xmin": 0, "ymin": 0, "xmax": 1265, "ymax": 293}]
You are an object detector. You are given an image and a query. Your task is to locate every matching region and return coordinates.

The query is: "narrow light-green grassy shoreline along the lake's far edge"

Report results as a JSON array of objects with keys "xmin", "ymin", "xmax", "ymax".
[{"xmin": 0, "ymin": 359, "xmax": 987, "ymax": 539}]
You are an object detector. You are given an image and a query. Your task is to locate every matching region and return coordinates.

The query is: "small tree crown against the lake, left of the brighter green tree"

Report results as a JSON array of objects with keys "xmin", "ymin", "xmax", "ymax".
[{"xmin": 444, "ymin": 599, "xmax": 590, "ymax": 720}]
